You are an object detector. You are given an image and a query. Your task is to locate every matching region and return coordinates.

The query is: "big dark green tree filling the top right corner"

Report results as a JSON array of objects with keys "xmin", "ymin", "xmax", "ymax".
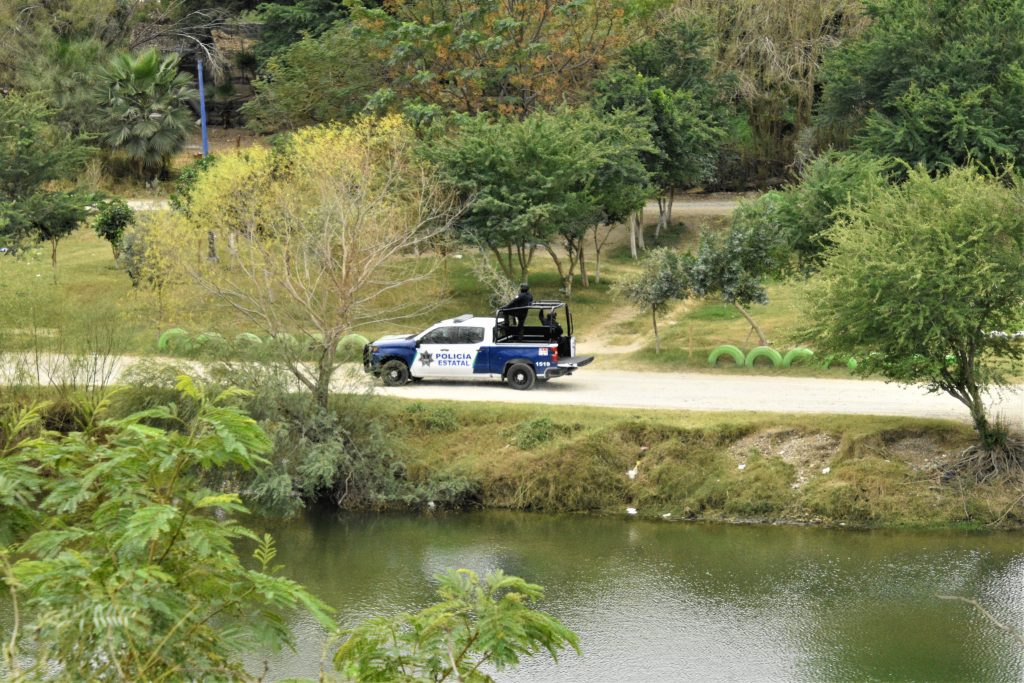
[{"xmin": 820, "ymin": 0, "xmax": 1024, "ymax": 173}]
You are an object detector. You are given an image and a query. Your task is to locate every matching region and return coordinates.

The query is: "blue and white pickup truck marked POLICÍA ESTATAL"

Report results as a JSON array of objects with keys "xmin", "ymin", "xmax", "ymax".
[{"xmin": 362, "ymin": 301, "xmax": 594, "ymax": 390}]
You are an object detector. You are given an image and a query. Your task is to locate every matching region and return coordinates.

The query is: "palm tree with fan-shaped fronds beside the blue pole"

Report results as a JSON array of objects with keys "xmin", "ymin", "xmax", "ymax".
[{"xmin": 97, "ymin": 50, "xmax": 198, "ymax": 178}]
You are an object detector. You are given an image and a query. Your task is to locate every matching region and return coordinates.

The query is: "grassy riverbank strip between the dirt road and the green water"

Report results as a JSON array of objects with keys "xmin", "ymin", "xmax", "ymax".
[{"xmin": 9, "ymin": 386, "xmax": 1024, "ymax": 529}]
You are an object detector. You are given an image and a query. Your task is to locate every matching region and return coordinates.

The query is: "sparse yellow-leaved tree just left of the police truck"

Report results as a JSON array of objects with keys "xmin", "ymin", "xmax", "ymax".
[{"xmin": 157, "ymin": 117, "xmax": 455, "ymax": 409}]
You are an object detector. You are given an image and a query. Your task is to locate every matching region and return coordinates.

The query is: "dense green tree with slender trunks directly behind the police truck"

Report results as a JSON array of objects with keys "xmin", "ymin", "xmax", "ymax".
[{"xmin": 426, "ymin": 108, "xmax": 650, "ymax": 294}]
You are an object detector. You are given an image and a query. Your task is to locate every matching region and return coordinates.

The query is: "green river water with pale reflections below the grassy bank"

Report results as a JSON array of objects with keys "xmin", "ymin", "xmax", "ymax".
[{"xmin": 252, "ymin": 512, "xmax": 1024, "ymax": 681}]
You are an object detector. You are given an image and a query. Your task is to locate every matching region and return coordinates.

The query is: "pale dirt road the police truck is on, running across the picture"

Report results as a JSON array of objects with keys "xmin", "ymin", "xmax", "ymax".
[{"xmin": 8, "ymin": 354, "xmax": 1024, "ymax": 427}]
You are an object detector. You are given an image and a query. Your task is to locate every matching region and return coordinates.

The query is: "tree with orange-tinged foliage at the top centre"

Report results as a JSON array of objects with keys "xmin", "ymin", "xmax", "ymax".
[{"xmin": 352, "ymin": 0, "xmax": 631, "ymax": 121}]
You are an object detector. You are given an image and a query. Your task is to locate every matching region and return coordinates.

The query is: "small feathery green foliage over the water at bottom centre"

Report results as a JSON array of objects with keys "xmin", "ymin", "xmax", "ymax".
[{"xmin": 334, "ymin": 569, "xmax": 580, "ymax": 682}]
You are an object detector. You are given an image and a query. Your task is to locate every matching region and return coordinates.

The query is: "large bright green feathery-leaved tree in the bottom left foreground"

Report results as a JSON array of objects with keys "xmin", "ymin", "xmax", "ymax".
[{"xmin": 0, "ymin": 377, "xmax": 337, "ymax": 681}]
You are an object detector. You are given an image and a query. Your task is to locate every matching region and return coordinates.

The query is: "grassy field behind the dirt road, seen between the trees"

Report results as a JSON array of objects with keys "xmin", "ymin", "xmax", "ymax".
[{"xmin": 0, "ymin": 206, "xmax": 846, "ymax": 375}]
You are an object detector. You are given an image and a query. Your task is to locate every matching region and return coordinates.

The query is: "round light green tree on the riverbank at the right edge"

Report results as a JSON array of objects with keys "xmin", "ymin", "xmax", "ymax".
[{"xmin": 806, "ymin": 168, "xmax": 1024, "ymax": 466}]
